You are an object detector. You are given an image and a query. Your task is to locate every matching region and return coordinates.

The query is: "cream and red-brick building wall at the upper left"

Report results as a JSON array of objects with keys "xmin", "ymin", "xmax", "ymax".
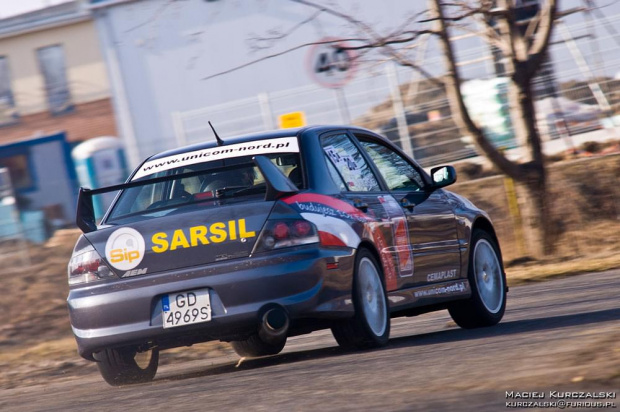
[{"xmin": 0, "ymin": 13, "xmax": 117, "ymax": 144}]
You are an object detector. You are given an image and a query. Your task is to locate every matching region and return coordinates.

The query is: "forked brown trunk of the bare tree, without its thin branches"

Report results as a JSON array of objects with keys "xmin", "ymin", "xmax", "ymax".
[{"xmin": 429, "ymin": 0, "xmax": 554, "ymax": 258}]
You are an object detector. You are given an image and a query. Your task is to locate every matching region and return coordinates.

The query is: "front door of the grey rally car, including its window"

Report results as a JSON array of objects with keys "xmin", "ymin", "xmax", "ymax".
[{"xmin": 356, "ymin": 135, "xmax": 460, "ymax": 285}]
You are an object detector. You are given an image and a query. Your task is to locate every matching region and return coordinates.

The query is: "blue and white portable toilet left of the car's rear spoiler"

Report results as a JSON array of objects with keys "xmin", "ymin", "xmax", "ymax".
[{"xmin": 71, "ymin": 136, "xmax": 127, "ymax": 218}]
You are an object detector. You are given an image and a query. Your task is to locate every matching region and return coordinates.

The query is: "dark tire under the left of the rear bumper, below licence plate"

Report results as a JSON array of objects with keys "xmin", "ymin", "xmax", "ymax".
[{"xmin": 93, "ymin": 347, "xmax": 159, "ymax": 386}]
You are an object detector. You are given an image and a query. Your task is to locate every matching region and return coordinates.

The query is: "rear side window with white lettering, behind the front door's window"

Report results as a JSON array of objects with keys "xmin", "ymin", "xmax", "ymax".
[{"xmin": 321, "ymin": 134, "xmax": 381, "ymax": 192}]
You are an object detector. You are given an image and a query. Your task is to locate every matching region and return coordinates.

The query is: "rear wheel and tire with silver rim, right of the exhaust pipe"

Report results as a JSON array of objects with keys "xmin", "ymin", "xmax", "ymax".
[{"xmin": 332, "ymin": 249, "xmax": 390, "ymax": 349}]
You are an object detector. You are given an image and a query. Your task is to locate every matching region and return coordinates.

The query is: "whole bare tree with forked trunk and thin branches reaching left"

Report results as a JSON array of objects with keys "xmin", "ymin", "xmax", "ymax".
[{"xmin": 206, "ymin": 0, "xmax": 558, "ymax": 255}]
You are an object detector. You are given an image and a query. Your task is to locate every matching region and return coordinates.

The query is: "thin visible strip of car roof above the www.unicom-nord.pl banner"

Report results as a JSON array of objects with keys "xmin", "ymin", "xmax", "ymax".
[{"xmin": 147, "ymin": 125, "xmax": 372, "ymax": 160}]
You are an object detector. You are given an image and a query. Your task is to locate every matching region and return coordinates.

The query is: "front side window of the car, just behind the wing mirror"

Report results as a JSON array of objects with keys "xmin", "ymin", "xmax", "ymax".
[{"xmin": 360, "ymin": 140, "xmax": 424, "ymax": 192}]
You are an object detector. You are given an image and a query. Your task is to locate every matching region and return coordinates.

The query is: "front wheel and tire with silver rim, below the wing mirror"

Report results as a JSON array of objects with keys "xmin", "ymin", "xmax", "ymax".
[{"xmin": 448, "ymin": 230, "xmax": 506, "ymax": 329}]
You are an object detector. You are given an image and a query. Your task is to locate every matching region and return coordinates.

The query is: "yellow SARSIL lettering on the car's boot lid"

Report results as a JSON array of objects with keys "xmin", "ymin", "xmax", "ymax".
[{"xmin": 151, "ymin": 219, "xmax": 256, "ymax": 253}]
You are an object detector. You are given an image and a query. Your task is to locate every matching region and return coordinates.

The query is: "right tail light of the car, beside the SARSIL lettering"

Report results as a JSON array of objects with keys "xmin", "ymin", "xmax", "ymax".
[{"xmin": 254, "ymin": 219, "xmax": 319, "ymax": 253}]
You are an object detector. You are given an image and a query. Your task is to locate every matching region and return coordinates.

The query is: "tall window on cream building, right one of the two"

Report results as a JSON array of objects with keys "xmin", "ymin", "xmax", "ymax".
[{"xmin": 37, "ymin": 45, "xmax": 73, "ymax": 114}]
